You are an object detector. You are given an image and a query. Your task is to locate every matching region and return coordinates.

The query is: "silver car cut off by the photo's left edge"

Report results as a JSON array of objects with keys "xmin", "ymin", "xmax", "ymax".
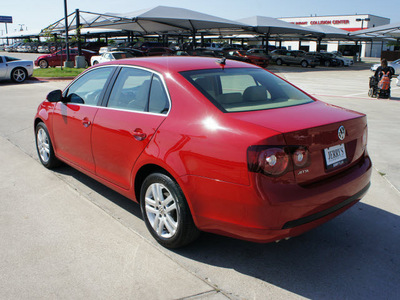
[{"xmin": 0, "ymin": 56, "xmax": 33, "ymax": 83}]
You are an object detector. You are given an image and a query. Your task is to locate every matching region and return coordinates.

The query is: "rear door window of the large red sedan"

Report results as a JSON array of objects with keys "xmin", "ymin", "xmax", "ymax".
[{"xmin": 107, "ymin": 68, "xmax": 153, "ymax": 112}]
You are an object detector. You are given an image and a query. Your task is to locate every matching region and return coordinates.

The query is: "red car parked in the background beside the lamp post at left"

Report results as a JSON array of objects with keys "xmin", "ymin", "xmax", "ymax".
[{"xmin": 35, "ymin": 48, "xmax": 97, "ymax": 69}]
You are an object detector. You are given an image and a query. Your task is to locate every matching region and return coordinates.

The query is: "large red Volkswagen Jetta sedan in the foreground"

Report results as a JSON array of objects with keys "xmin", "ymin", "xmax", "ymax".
[{"xmin": 34, "ymin": 57, "xmax": 372, "ymax": 248}]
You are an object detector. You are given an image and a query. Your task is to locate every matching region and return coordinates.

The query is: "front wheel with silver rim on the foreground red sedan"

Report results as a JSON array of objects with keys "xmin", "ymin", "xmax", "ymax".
[{"xmin": 35, "ymin": 122, "xmax": 60, "ymax": 169}]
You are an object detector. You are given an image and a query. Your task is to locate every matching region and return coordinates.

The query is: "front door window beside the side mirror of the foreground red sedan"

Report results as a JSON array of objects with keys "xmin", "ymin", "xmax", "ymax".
[{"xmin": 65, "ymin": 68, "xmax": 113, "ymax": 105}]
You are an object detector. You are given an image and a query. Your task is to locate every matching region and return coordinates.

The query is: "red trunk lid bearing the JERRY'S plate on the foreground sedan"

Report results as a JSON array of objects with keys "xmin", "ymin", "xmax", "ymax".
[{"xmin": 232, "ymin": 101, "xmax": 367, "ymax": 184}]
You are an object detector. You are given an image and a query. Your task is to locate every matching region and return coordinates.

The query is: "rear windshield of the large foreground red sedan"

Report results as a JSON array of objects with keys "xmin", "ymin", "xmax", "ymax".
[{"xmin": 181, "ymin": 68, "xmax": 314, "ymax": 112}]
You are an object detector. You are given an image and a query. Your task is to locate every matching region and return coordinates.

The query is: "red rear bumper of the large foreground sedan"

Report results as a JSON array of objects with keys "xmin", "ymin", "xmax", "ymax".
[{"xmin": 185, "ymin": 156, "xmax": 372, "ymax": 242}]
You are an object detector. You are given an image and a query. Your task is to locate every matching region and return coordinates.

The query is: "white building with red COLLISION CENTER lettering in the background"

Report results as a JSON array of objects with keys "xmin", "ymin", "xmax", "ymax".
[{"xmin": 279, "ymin": 14, "xmax": 390, "ymax": 57}]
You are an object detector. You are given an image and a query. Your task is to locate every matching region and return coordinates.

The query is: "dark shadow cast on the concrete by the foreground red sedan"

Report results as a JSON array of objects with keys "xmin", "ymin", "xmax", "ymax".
[{"xmin": 50, "ymin": 165, "xmax": 400, "ymax": 299}]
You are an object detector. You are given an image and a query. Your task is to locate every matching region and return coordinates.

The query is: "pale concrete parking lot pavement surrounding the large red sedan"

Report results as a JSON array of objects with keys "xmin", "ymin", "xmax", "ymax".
[{"xmin": 0, "ymin": 64, "xmax": 400, "ymax": 299}]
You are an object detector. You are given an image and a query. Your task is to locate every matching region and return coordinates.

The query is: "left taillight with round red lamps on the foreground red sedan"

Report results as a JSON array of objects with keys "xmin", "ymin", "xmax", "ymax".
[{"xmin": 247, "ymin": 146, "xmax": 310, "ymax": 177}]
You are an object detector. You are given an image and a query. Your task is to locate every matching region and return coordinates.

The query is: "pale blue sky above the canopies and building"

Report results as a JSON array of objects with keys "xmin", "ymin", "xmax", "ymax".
[{"xmin": 0, "ymin": 0, "xmax": 400, "ymax": 35}]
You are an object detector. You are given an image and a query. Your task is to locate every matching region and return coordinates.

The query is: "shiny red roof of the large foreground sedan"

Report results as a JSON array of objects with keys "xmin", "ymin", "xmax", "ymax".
[{"xmin": 97, "ymin": 56, "xmax": 258, "ymax": 73}]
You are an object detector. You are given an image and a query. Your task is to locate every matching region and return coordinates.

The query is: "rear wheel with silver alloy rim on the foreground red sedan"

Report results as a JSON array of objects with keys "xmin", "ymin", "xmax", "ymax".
[{"xmin": 140, "ymin": 173, "xmax": 200, "ymax": 249}]
